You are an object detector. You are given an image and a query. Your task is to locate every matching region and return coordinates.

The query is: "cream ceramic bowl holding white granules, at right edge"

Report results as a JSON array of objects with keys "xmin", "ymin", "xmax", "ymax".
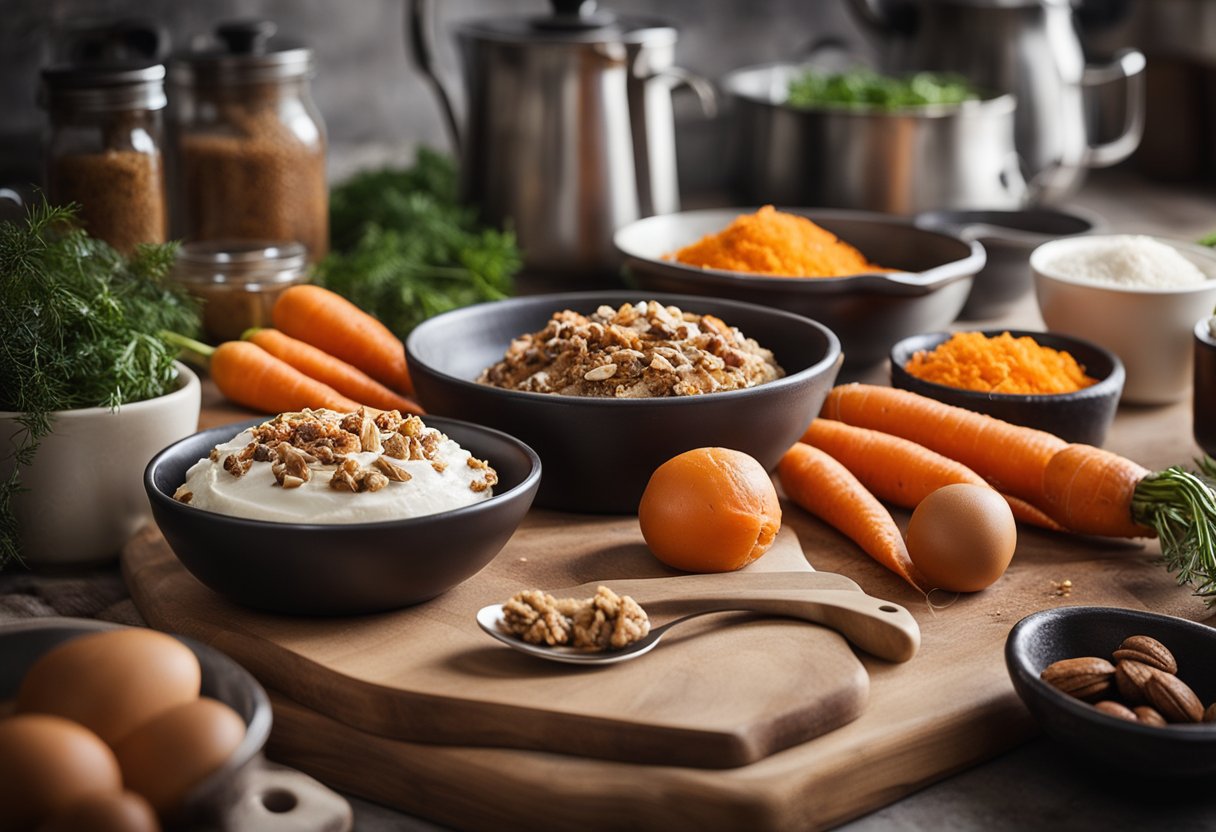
[{"xmin": 1030, "ymin": 235, "xmax": 1216, "ymax": 405}]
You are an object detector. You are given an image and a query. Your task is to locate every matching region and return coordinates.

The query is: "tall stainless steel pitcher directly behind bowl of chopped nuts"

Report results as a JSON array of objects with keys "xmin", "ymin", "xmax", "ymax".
[{"xmin": 409, "ymin": 0, "xmax": 714, "ymax": 272}]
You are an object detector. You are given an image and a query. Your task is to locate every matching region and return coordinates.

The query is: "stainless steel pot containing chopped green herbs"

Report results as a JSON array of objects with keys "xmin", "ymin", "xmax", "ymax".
[{"xmin": 721, "ymin": 63, "xmax": 1028, "ymax": 214}]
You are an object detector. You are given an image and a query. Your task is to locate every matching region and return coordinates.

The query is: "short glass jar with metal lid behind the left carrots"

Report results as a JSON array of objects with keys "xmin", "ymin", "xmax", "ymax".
[{"xmin": 173, "ymin": 240, "xmax": 308, "ymax": 343}]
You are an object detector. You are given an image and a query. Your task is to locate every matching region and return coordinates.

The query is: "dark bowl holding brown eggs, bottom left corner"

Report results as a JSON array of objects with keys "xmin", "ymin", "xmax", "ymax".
[{"xmin": 0, "ymin": 618, "xmax": 271, "ymax": 828}]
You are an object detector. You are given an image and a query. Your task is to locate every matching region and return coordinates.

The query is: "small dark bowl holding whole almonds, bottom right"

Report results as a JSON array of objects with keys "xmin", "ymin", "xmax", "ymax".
[{"xmin": 1004, "ymin": 607, "xmax": 1216, "ymax": 777}]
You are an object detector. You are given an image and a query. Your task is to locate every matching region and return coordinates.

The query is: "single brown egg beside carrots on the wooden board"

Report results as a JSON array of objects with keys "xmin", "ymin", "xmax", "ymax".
[{"xmin": 907, "ymin": 484, "xmax": 1018, "ymax": 592}]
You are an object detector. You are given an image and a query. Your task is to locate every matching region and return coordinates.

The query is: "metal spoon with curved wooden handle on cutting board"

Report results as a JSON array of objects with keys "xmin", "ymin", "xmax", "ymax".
[{"xmin": 477, "ymin": 575, "xmax": 921, "ymax": 665}]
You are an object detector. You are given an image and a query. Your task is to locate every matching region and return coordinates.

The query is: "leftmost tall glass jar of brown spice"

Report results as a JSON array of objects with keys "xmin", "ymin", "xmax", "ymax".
[{"xmin": 40, "ymin": 64, "xmax": 167, "ymax": 254}]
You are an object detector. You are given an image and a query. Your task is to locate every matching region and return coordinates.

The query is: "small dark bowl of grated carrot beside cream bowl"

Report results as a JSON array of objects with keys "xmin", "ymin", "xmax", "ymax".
[{"xmin": 890, "ymin": 330, "xmax": 1125, "ymax": 445}]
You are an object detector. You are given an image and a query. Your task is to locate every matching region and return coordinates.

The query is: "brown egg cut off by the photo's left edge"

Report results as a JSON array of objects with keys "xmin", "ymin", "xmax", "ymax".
[{"xmin": 0, "ymin": 714, "xmax": 123, "ymax": 832}]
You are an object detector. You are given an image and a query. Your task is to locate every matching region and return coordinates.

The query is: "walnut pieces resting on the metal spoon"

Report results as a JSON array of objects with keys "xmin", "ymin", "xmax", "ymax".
[{"xmin": 501, "ymin": 586, "xmax": 651, "ymax": 652}]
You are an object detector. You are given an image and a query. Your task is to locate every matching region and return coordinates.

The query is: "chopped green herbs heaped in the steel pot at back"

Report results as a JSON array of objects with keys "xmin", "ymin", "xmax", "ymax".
[{"xmin": 786, "ymin": 69, "xmax": 979, "ymax": 109}]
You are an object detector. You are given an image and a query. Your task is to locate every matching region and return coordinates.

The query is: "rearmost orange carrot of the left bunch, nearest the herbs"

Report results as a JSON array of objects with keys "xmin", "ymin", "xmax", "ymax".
[{"xmin": 271, "ymin": 283, "xmax": 413, "ymax": 395}]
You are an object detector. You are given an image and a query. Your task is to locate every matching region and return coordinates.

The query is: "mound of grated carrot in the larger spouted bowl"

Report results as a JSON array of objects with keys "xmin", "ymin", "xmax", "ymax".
[{"xmin": 669, "ymin": 206, "xmax": 889, "ymax": 277}]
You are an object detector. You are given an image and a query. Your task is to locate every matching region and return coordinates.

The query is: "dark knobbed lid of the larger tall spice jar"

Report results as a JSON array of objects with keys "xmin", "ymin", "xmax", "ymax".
[{"xmin": 173, "ymin": 19, "xmax": 313, "ymax": 86}]
